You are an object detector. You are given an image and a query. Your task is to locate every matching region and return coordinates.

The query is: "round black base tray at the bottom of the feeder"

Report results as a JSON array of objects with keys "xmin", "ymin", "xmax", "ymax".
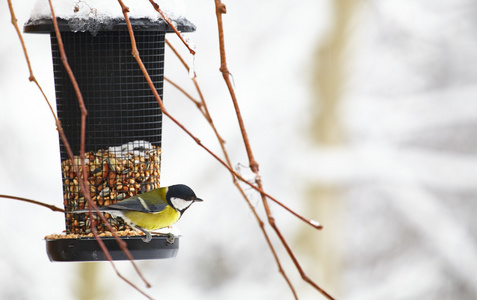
[{"xmin": 46, "ymin": 235, "xmax": 179, "ymax": 261}]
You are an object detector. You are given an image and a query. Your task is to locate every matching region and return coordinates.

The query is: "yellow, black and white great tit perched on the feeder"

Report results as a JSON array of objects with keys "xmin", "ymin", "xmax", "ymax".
[{"xmin": 72, "ymin": 184, "xmax": 203, "ymax": 243}]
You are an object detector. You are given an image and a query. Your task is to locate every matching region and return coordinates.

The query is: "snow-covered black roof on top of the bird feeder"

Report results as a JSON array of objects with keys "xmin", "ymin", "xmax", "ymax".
[{"xmin": 24, "ymin": 0, "xmax": 196, "ymax": 35}]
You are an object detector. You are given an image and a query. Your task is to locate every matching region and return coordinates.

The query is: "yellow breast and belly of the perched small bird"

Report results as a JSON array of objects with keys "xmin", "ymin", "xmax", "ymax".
[{"xmin": 123, "ymin": 205, "xmax": 180, "ymax": 230}]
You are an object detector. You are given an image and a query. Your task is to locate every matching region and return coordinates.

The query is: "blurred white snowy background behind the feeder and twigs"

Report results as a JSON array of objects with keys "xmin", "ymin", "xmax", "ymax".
[{"xmin": 0, "ymin": 0, "xmax": 477, "ymax": 299}]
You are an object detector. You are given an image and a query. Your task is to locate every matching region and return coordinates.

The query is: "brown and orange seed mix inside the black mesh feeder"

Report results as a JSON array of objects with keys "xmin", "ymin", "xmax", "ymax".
[{"xmin": 61, "ymin": 141, "xmax": 161, "ymax": 235}]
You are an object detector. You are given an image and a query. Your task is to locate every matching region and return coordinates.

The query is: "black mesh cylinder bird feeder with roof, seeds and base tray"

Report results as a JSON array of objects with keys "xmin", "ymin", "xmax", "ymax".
[{"xmin": 24, "ymin": 6, "xmax": 195, "ymax": 261}]
